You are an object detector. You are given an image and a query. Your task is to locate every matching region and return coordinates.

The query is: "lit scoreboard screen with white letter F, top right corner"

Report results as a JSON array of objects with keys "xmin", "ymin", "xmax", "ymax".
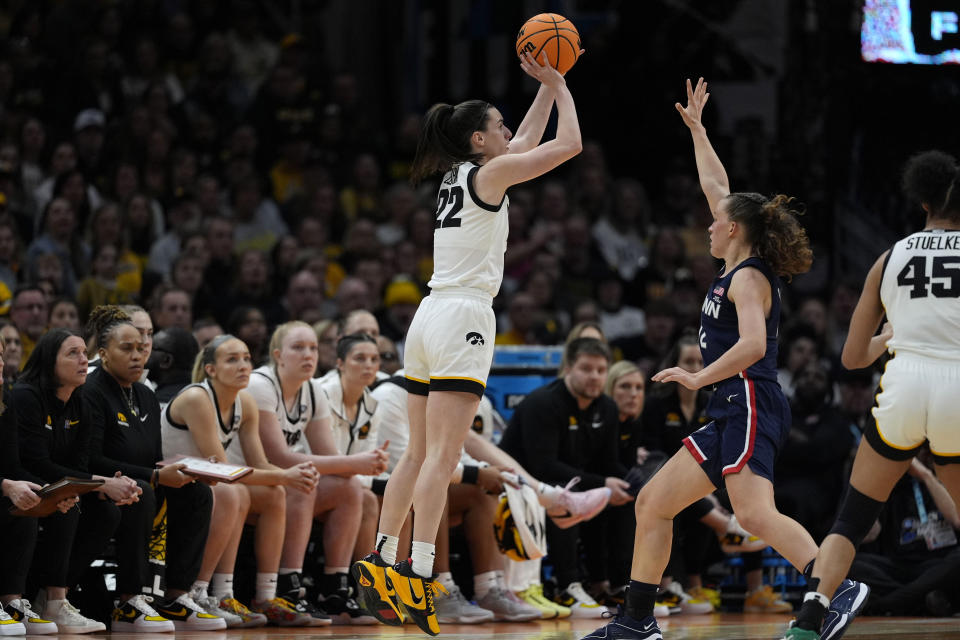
[{"xmin": 860, "ymin": 0, "xmax": 960, "ymax": 65}]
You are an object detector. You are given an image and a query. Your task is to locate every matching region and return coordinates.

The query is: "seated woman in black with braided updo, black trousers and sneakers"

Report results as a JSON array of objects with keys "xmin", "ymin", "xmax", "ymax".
[{"xmin": 82, "ymin": 305, "xmax": 226, "ymax": 631}]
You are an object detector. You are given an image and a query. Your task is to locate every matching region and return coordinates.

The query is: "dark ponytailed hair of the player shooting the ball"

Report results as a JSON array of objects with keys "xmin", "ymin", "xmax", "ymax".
[{"xmin": 410, "ymin": 100, "xmax": 490, "ymax": 185}]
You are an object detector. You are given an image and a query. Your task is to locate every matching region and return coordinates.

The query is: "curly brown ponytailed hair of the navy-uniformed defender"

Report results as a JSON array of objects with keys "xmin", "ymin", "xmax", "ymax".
[{"xmin": 727, "ymin": 193, "xmax": 813, "ymax": 278}]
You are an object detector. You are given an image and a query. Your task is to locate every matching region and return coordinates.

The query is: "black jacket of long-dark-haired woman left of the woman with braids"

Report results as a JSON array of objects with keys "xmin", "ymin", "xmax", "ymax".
[{"xmin": 10, "ymin": 382, "xmax": 91, "ymax": 482}]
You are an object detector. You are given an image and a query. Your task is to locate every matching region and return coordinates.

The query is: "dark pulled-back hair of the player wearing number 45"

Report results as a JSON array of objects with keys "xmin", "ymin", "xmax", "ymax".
[{"xmin": 902, "ymin": 151, "xmax": 960, "ymax": 222}]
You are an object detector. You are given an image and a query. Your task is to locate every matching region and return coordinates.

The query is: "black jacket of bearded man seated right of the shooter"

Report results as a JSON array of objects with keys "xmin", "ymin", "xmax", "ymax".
[{"xmin": 500, "ymin": 378, "xmax": 627, "ymax": 489}]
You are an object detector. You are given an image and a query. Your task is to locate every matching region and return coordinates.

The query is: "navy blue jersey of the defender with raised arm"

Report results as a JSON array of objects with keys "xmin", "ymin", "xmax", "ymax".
[{"xmin": 700, "ymin": 257, "xmax": 780, "ymax": 384}]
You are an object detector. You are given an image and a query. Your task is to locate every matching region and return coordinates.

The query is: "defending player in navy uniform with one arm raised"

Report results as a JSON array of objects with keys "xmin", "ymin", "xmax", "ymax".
[{"xmin": 586, "ymin": 78, "xmax": 866, "ymax": 640}]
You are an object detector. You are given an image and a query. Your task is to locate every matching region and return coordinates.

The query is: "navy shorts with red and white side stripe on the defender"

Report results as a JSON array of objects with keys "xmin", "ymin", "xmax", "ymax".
[{"xmin": 683, "ymin": 378, "xmax": 791, "ymax": 489}]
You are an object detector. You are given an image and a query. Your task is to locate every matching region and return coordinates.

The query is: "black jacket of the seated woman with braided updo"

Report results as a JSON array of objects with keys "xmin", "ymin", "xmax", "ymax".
[{"xmin": 81, "ymin": 367, "xmax": 163, "ymax": 481}]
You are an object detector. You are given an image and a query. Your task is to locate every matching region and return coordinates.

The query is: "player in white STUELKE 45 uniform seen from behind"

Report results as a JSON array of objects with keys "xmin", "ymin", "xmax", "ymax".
[{"xmin": 786, "ymin": 151, "xmax": 960, "ymax": 640}]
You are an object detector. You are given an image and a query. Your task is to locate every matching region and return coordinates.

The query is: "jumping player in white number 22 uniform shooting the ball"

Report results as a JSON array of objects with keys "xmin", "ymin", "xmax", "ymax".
[{"xmin": 353, "ymin": 55, "xmax": 581, "ymax": 635}]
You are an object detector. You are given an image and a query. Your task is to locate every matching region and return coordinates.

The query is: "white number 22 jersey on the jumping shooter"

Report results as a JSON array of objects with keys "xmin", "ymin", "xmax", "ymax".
[{"xmin": 427, "ymin": 162, "xmax": 509, "ymax": 298}]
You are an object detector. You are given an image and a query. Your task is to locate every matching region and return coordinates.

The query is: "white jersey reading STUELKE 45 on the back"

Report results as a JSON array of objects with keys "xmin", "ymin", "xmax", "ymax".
[{"xmin": 880, "ymin": 229, "xmax": 960, "ymax": 361}]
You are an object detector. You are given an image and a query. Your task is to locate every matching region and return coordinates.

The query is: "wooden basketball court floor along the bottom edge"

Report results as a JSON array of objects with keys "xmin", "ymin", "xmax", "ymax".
[{"xmin": 101, "ymin": 613, "xmax": 960, "ymax": 640}]
